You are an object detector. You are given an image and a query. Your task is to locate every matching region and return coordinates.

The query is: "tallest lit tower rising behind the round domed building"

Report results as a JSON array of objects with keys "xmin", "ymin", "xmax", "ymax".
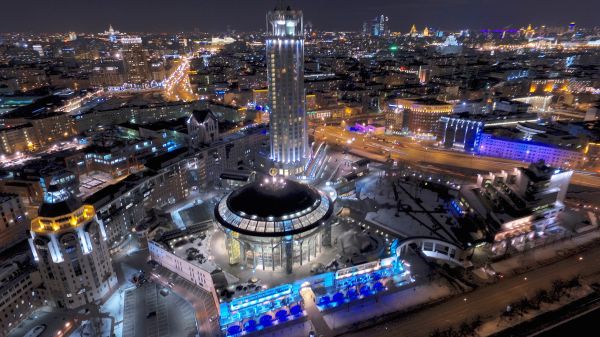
[{"xmin": 266, "ymin": 5, "xmax": 310, "ymax": 176}]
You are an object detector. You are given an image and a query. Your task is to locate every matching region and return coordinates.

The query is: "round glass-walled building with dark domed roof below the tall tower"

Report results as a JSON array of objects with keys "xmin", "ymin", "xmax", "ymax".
[{"xmin": 215, "ymin": 177, "xmax": 333, "ymax": 273}]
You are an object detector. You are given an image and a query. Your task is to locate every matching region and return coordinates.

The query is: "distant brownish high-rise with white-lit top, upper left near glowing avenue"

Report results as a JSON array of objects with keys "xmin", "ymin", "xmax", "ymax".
[{"xmin": 121, "ymin": 37, "xmax": 152, "ymax": 84}]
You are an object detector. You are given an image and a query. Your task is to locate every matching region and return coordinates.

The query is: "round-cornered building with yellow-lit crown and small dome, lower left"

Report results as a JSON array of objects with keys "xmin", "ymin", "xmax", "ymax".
[{"xmin": 29, "ymin": 185, "xmax": 117, "ymax": 308}]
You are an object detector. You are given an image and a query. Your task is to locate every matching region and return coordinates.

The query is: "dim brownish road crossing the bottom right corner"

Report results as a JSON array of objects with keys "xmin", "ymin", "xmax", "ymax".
[{"xmin": 346, "ymin": 240, "xmax": 600, "ymax": 337}]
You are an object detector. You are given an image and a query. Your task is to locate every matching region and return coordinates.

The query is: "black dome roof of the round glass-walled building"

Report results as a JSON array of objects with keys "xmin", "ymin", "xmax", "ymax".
[{"xmin": 227, "ymin": 178, "xmax": 321, "ymax": 218}]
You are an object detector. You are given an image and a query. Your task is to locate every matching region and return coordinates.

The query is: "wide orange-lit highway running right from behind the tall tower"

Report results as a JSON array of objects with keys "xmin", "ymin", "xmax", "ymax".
[{"xmin": 314, "ymin": 126, "xmax": 600, "ymax": 188}]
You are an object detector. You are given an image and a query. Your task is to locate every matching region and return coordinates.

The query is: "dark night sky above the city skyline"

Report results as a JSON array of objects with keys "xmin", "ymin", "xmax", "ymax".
[{"xmin": 0, "ymin": 0, "xmax": 600, "ymax": 32}]
